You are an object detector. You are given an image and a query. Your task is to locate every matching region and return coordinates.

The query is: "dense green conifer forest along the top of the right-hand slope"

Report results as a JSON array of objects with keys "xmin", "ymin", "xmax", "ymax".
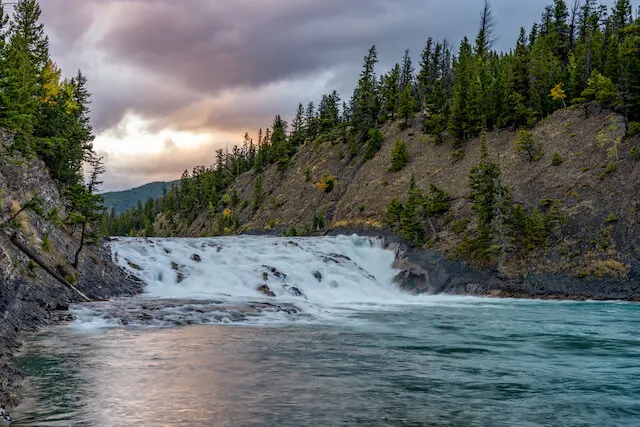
[{"xmin": 107, "ymin": 0, "xmax": 640, "ymax": 240}]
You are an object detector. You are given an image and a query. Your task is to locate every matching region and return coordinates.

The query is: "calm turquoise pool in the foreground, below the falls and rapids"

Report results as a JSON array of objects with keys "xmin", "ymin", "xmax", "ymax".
[{"xmin": 13, "ymin": 297, "xmax": 640, "ymax": 426}]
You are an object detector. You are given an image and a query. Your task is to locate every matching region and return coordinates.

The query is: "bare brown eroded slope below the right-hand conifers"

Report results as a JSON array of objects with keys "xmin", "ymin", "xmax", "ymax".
[{"xmin": 156, "ymin": 106, "xmax": 640, "ymax": 297}]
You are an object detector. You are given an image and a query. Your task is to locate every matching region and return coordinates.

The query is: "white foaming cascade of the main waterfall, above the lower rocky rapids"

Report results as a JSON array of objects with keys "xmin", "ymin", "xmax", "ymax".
[{"xmin": 111, "ymin": 236, "xmax": 407, "ymax": 307}]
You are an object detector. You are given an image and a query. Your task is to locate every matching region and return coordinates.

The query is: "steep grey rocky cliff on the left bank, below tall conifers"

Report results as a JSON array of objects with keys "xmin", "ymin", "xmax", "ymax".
[{"xmin": 0, "ymin": 139, "xmax": 140, "ymax": 407}]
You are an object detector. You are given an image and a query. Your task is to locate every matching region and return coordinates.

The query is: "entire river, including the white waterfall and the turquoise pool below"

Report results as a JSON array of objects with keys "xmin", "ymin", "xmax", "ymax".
[{"xmin": 12, "ymin": 236, "xmax": 640, "ymax": 426}]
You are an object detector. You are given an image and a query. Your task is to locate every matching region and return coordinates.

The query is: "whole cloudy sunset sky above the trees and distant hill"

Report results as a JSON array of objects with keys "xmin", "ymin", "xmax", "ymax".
[{"xmin": 40, "ymin": 0, "xmax": 640, "ymax": 191}]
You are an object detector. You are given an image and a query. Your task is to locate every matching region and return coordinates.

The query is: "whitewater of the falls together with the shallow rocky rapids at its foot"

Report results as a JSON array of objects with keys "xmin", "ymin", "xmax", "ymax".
[{"xmin": 74, "ymin": 235, "xmax": 430, "ymax": 328}]
